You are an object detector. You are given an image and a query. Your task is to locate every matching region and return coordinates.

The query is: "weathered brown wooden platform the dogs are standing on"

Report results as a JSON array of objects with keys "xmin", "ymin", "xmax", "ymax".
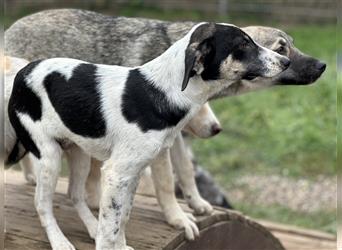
[{"xmin": 5, "ymin": 170, "xmax": 336, "ymax": 250}]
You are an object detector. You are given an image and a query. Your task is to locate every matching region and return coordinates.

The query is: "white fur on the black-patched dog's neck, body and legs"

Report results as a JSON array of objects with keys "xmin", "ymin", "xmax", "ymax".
[{"xmin": 6, "ymin": 24, "xmax": 288, "ymax": 249}]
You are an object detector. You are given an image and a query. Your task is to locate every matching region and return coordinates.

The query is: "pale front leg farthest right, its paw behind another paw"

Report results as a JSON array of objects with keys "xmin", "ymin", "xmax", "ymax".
[{"xmin": 170, "ymin": 134, "xmax": 213, "ymax": 214}]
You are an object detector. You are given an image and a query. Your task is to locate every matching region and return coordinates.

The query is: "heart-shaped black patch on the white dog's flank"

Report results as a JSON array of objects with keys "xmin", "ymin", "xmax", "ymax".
[{"xmin": 44, "ymin": 63, "xmax": 106, "ymax": 138}]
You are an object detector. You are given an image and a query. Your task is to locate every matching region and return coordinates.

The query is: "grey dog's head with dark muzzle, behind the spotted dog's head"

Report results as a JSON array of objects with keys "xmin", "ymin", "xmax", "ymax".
[{"xmin": 211, "ymin": 26, "xmax": 326, "ymax": 99}]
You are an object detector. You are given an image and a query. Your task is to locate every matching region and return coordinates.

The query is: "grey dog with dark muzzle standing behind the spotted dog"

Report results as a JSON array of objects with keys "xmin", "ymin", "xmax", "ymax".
[{"xmin": 5, "ymin": 9, "xmax": 326, "ymax": 211}]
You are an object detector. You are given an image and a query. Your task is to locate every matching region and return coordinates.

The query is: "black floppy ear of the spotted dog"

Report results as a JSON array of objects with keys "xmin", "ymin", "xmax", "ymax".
[{"xmin": 182, "ymin": 23, "xmax": 216, "ymax": 91}]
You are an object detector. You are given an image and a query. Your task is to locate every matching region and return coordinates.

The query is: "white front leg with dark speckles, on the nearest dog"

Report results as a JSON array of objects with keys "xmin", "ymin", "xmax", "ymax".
[{"xmin": 96, "ymin": 160, "xmax": 140, "ymax": 250}]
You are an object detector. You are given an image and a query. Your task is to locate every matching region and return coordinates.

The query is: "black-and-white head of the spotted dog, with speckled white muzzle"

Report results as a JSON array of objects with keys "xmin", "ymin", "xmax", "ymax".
[{"xmin": 182, "ymin": 23, "xmax": 290, "ymax": 90}]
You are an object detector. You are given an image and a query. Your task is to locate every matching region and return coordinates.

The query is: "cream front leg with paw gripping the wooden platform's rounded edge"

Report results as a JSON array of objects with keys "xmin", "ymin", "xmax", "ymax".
[{"xmin": 151, "ymin": 149, "xmax": 199, "ymax": 240}]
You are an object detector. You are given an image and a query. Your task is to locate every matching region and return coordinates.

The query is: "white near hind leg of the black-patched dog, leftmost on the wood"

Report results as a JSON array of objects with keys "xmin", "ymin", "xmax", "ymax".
[{"xmin": 32, "ymin": 139, "xmax": 75, "ymax": 250}]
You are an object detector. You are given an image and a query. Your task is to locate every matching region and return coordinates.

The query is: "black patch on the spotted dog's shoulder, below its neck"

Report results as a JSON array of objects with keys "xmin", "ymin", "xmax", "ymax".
[{"xmin": 121, "ymin": 69, "xmax": 188, "ymax": 132}]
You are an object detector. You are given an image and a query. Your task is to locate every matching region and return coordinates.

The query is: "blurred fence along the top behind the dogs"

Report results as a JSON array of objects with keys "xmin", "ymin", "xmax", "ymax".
[{"xmin": 6, "ymin": 0, "xmax": 338, "ymax": 22}]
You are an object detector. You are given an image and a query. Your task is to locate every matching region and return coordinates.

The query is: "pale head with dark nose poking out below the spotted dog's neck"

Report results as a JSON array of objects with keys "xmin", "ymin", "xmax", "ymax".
[{"xmin": 183, "ymin": 103, "xmax": 222, "ymax": 138}]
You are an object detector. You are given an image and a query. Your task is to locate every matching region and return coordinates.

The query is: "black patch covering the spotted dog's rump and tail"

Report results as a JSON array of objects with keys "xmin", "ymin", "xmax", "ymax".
[{"xmin": 8, "ymin": 60, "xmax": 42, "ymax": 159}]
